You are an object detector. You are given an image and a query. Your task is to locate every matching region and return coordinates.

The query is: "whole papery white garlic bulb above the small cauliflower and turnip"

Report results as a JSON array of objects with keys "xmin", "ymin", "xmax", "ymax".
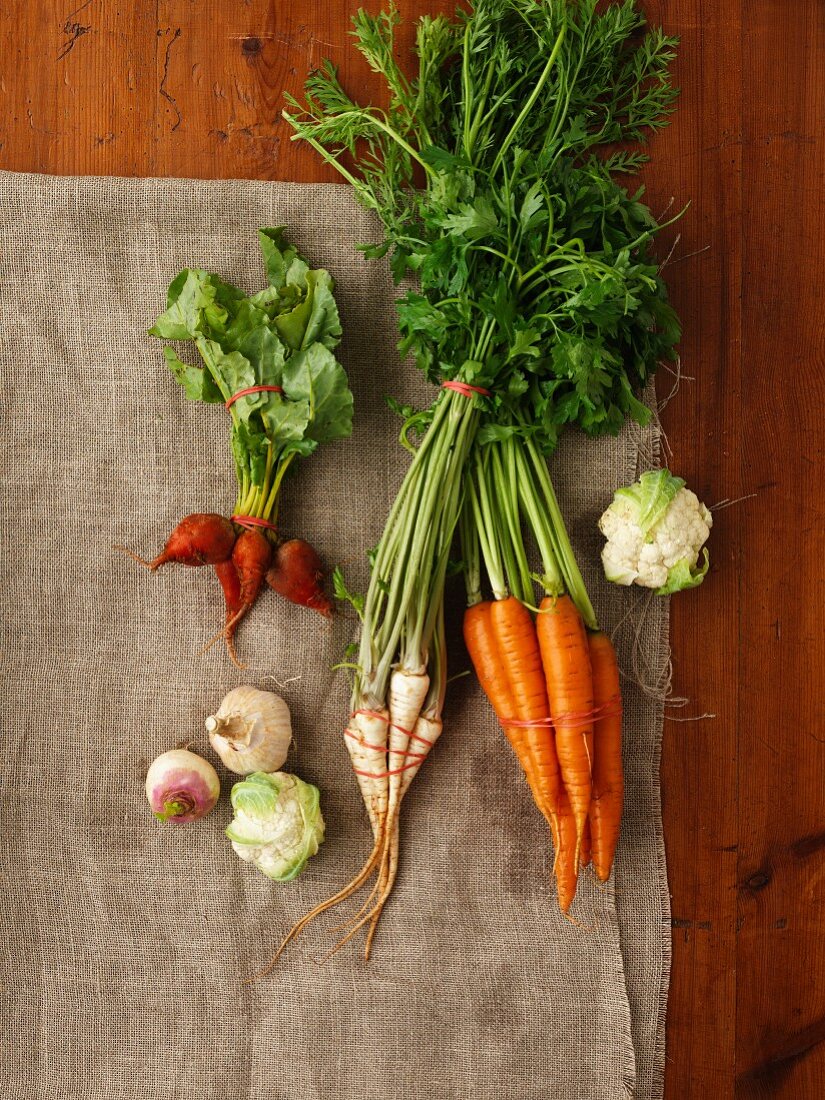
[{"xmin": 206, "ymin": 684, "xmax": 293, "ymax": 776}]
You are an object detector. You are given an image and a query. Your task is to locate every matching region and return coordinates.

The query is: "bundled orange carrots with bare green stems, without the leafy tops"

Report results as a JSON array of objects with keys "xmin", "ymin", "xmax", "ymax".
[{"xmin": 461, "ymin": 439, "xmax": 624, "ymax": 913}]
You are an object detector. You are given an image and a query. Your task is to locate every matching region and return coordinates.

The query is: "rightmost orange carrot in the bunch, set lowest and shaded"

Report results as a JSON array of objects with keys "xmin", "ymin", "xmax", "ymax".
[{"xmin": 589, "ymin": 633, "xmax": 625, "ymax": 882}]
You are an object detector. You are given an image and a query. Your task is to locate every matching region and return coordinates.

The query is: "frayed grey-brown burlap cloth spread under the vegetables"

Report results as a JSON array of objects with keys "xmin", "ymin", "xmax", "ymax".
[{"xmin": 0, "ymin": 174, "xmax": 669, "ymax": 1100}]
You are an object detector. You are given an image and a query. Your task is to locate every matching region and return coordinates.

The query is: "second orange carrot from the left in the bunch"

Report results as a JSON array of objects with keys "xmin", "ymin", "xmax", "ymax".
[{"xmin": 490, "ymin": 596, "xmax": 561, "ymax": 820}]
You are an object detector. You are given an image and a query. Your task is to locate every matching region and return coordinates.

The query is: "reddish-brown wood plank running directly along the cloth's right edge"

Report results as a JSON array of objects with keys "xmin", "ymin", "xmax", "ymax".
[{"xmin": 645, "ymin": 0, "xmax": 741, "ymax": 1100}]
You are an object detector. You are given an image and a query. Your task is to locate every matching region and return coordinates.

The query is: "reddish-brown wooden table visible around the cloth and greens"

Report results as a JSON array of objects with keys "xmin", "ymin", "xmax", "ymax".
[{"xmin": 0, "ymin": 0, "xmax": 825, "ymax": 1100}]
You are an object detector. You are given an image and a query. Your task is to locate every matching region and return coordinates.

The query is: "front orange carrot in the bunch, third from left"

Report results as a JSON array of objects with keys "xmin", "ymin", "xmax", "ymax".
[{"xmin": 537, "ymin": 596, "xmax": 593, "ymax": 844}]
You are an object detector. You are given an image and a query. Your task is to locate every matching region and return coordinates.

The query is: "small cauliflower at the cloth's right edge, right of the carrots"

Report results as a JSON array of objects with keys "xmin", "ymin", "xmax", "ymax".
[{"xmin": 598, "ymin": 470, "xmax": 713, "ymax": 595}]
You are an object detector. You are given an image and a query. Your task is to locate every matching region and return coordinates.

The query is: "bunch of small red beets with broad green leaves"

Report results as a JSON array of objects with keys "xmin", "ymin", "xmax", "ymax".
[{"xmin": 130, "ymin": 227, "xmax": 353, "ymax": 663}]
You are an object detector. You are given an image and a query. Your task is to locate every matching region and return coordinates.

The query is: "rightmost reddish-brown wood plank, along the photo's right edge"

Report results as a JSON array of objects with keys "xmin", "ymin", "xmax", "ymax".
[{"xmin": 732, "ymin": 0, "xmax": 825, "ymax": 1100}]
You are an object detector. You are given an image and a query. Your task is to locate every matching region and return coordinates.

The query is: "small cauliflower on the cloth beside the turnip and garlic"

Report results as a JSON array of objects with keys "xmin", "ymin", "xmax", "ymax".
[{"xmin": 227, "ymin": 771, "xmax": 323, "ymax": 882}]
